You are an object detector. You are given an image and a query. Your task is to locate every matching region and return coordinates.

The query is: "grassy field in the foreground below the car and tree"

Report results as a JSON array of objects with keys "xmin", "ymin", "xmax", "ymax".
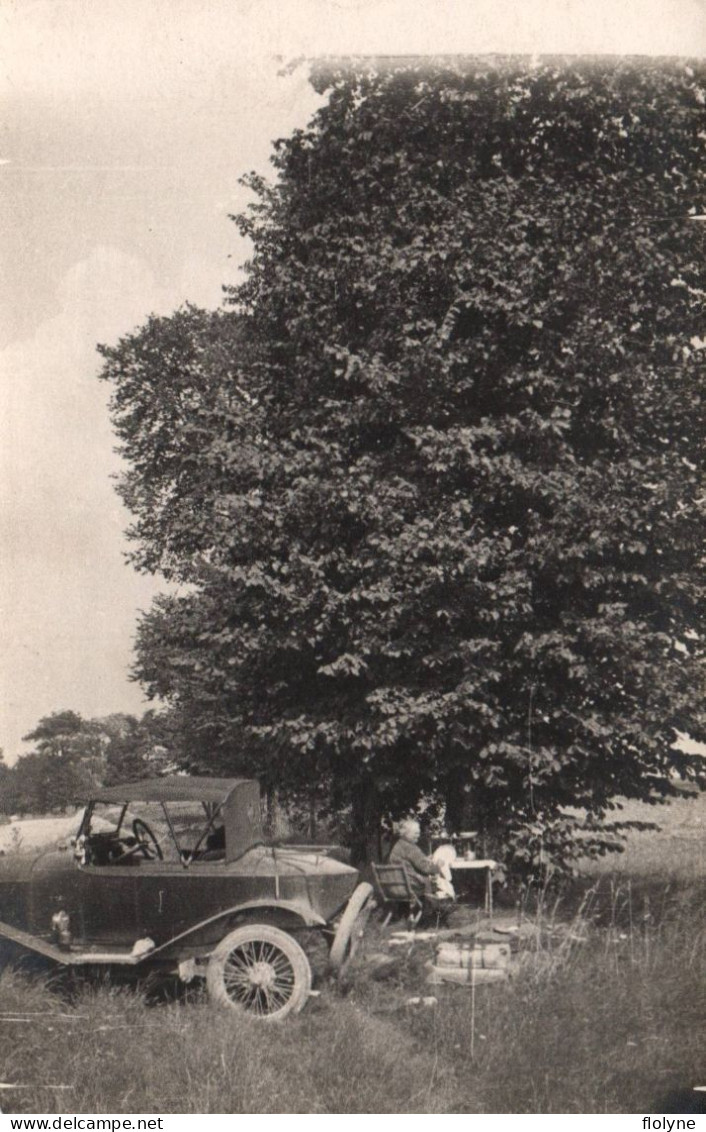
[{"xmin": 0, "ymin": 798, "xmax": 706, "ymax": 1114}]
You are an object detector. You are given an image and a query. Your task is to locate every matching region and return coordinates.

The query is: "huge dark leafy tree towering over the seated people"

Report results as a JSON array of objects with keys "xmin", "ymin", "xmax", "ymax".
[{"xmin": 102, "ymin": 59, "xmax": 706, "ymax": 860}]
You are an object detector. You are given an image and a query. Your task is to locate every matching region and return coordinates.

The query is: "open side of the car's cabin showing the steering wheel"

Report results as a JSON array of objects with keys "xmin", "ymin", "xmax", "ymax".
[{"xmin": 83, "ymin": 801, "xmax": 221, "ymax": 860}]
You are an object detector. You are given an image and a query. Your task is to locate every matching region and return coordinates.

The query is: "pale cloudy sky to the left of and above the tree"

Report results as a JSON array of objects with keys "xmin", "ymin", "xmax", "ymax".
[{"xmin": 0, "ymin": 0, "xmax": 706, "ymax": 762}]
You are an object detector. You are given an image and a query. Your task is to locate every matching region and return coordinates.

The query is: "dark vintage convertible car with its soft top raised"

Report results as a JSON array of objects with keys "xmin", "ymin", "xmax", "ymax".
[{"xmin": 0, "ymin": 775, "xmax": 372, "ymax": 1019}]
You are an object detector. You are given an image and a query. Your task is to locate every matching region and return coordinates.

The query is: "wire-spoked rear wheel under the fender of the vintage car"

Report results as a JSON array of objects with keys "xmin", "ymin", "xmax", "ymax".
[{"xmin": 206, "ymin": 924, "xmax": 311, "ymax": 1022}]
